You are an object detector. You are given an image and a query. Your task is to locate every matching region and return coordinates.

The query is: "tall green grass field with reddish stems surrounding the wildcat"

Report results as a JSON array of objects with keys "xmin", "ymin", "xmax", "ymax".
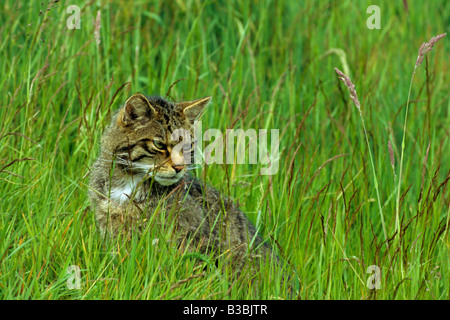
[{"xmin": 0, "ymin": 0, "xmax": 450, "ymax": 299}]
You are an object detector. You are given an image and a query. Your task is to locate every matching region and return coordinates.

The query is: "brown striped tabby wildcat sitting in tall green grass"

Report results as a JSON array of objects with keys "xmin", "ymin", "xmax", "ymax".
[{"xmin": 89, "ymin": 94, "xmax": 277, "ymax": 278}]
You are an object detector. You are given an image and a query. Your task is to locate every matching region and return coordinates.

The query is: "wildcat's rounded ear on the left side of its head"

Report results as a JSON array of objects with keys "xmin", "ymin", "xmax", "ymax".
[{"xmin": 117, "ymin": 93, "xmax": 156, "ymax": 126}]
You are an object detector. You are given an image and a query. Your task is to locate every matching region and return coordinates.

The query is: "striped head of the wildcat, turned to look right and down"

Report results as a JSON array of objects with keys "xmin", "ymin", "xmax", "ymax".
[{"xmin": 102, "ymin": 93, "xmax": 211, "ymax": 186}]
